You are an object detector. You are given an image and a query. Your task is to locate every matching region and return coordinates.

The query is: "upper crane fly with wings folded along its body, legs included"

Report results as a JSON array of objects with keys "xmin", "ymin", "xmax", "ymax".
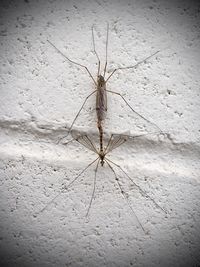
[{"xmin": 48, "ymin": 23, "xmax": 162, "ymax": 149}]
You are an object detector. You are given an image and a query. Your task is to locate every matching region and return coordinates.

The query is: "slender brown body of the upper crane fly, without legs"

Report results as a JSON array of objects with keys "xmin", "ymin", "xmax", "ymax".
[{"xmin": 96, "ymin": 75, "xmax": 107, "ymax": 156}]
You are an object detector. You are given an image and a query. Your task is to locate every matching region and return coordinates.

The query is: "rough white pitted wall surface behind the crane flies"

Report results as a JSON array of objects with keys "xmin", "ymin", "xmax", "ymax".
[{"xmin": 0, "ymin": 0, "xmax": 200, "ymax": 267}]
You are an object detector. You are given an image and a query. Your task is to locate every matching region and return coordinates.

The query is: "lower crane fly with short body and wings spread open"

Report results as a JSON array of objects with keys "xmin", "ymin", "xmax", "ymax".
[{"xmin": 36, "ymin": 131, "xmax": 167, "ymax": 232}]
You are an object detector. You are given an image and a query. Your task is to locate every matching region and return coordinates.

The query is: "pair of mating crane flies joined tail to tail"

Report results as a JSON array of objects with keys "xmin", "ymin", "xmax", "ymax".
[{"xmin": 39, "ymin": 24, "xmax": 166, "ymax": 230}]
